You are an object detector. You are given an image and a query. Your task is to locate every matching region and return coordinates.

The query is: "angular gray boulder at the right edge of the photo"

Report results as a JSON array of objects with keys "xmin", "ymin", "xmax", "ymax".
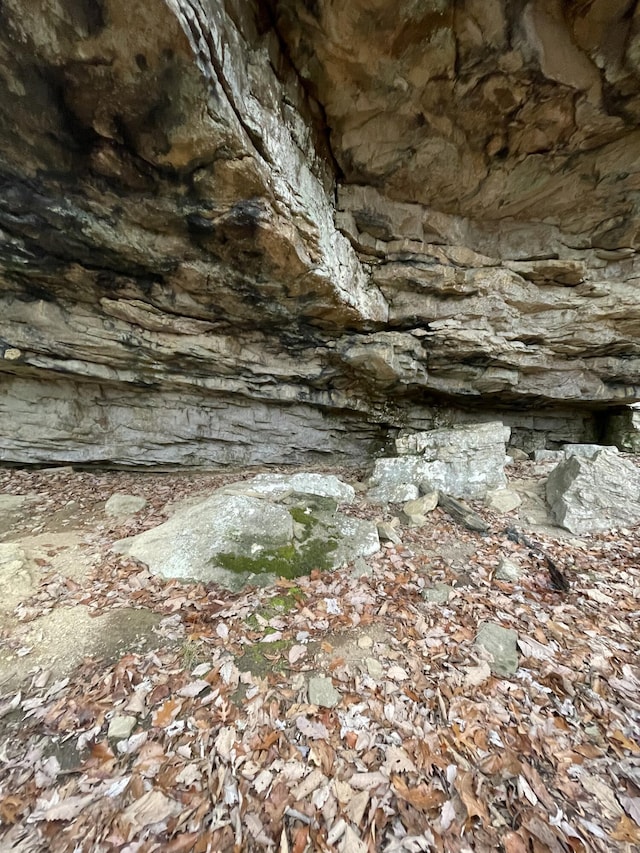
[{"xmin": 546, "ymin": 450, "xmax": 640, "ymax": 534}]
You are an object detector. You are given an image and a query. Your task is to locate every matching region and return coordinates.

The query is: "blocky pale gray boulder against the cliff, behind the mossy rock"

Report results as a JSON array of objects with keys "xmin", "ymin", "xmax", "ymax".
[{"xmin": 368, "ymin": 422, "xmax": 510, "ymax": 503}]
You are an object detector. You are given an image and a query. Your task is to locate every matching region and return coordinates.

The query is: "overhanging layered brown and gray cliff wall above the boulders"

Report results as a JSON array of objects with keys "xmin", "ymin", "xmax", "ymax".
[{"xmin": 0, "ymin": 0, "xmax": 640, "ymax": 465}]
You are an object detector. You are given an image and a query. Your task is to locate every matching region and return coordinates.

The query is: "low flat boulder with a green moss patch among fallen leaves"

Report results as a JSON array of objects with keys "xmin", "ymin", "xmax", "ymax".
[{"xmin": 113, "ymin": 474, "xmax": 380, "ymax": 590}]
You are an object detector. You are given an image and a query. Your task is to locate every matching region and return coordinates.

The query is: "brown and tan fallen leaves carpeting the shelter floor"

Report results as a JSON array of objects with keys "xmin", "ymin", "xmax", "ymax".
[{"xmin": 0, "ymin": 462, "xmax": 640, "ymax": 853}]
